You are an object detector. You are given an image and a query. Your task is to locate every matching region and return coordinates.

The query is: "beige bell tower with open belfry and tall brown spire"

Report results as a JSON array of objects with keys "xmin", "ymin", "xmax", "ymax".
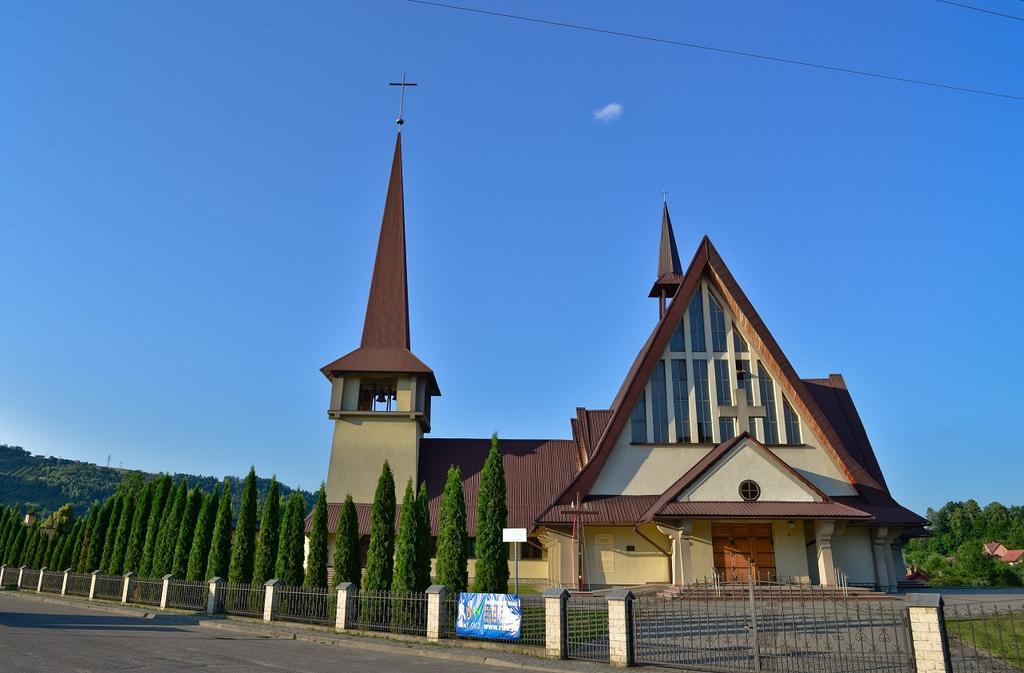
[{"xmin": 321, "ymin": 131, "xmax": 440, "ymax": 503}]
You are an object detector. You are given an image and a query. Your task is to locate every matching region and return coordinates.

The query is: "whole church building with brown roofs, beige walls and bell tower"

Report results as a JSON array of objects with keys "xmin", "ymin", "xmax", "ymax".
[{"xmin": 307, "ymin": 131, "xmax": 927, "ymax": 591}]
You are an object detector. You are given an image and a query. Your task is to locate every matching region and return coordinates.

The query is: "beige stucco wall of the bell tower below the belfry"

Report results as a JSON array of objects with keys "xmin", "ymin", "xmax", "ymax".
[{"xmin": 327, "ymin": 413, "xmax": 420, "ymax": 503}]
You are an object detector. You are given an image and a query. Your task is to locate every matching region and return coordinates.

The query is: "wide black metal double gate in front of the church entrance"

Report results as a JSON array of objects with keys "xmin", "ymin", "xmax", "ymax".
[{"xmin": 634, "ymin": 582, "xmax": 914, "ymax": 673}]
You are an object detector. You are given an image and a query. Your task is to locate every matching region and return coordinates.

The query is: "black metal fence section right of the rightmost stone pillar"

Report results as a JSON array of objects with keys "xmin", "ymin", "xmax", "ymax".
[{"xmin": 944, "ymin": 603, "xmax": 1024, "ymax": 673}]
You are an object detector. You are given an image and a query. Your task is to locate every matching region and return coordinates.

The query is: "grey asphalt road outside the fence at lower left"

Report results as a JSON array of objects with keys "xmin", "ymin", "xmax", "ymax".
[{"xmin": 0, "ymin": 595, "xmax": 480, "ymax": 673}]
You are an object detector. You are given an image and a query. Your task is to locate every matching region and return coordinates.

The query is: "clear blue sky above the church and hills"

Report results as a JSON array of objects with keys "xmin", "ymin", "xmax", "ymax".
[{"xmin": 0, "ymin": 0, "xmax": 1024, "ymax": 511}]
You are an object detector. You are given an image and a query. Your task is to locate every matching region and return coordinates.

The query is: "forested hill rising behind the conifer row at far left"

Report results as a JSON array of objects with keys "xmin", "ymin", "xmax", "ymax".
[{"xmin": 0, "ymin": 444, "xmax": 315, "ymax": 515}]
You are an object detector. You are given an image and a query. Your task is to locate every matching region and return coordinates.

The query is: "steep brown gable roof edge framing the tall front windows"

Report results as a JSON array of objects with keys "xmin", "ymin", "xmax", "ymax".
[{"xmin": 557, "ymin": 236, "xmax": 891, "ymax": 504}]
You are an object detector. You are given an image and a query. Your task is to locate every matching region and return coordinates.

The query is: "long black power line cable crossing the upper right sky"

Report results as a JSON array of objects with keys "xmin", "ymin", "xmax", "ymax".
[{"xmin": 407, "ymin": 0, "xmax": 1024, "ymax": 101}]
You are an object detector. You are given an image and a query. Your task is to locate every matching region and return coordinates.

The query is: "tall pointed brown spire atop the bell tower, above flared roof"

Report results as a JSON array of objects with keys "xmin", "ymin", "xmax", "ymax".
[{"xmin": 359, "ymin": 131, "xmax": 410, "ymax": 349}]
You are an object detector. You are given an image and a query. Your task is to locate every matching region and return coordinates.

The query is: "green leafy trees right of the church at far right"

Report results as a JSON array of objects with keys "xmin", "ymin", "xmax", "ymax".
[{"xmin": 904, "ymin": 500, "xmax": 1024, "ymax": 586}]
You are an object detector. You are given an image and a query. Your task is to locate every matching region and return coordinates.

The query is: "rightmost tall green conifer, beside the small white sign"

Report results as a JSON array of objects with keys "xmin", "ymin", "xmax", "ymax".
[{"xmin": 473, "ymin": 432, "xmax": 509, "ymax": 593}]
